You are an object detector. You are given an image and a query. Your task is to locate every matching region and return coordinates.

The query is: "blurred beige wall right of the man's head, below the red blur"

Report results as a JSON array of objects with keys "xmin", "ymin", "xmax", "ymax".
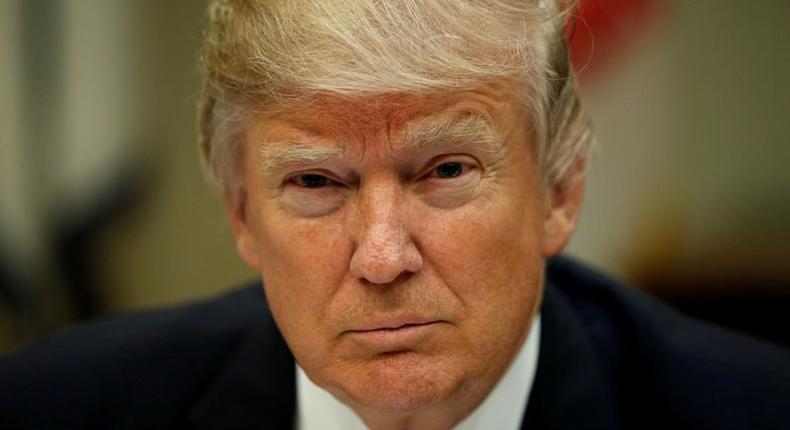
[{"xmin": 571, "ymin": 0, "xmax": 790, "ymax": 282}]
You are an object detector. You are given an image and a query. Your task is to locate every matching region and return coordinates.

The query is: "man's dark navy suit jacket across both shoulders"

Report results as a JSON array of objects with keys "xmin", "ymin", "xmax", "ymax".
[{"xmin": 0, "ymin": 259, "xmax": 790, "ymax": 430}]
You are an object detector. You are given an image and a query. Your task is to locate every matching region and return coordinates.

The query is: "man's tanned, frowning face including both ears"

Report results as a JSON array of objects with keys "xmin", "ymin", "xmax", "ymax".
[{"xmin": 226, "ymin": 83, "xmax": 584, "ymax": 429}]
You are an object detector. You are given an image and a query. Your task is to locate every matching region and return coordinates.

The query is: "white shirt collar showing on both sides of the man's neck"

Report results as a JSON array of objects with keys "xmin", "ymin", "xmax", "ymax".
[{"xmin": 295, "ymin": 315, "xmax": 540, "ymax": 430}]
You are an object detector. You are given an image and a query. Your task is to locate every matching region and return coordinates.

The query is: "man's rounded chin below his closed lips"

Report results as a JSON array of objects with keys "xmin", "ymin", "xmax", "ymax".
[{"xmin": 341, "ymin": 352, "xmax": 465, "ymax": 413}]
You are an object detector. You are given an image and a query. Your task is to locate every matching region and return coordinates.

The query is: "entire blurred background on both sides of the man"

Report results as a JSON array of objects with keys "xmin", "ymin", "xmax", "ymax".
[{"xmin": 0, "ymin": 0, "xmax": 790, "ymax": 353}]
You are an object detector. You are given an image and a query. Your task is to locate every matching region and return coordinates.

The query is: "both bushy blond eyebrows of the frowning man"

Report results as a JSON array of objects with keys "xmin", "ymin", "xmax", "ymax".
[{"xmin": 258, "ymin": 112, "xmax": 504, "ymax": 180}]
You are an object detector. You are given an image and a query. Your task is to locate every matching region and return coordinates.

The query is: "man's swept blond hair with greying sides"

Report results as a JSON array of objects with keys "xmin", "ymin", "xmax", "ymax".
[{"xmin": 199, "ymin": 0, "xmax": 592, "ymax": 192}]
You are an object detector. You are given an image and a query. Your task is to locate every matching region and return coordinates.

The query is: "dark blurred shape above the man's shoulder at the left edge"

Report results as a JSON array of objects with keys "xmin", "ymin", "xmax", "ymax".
[{"xmin": 0, "ymin": 166, "xmax": 144, "ymax": 352}]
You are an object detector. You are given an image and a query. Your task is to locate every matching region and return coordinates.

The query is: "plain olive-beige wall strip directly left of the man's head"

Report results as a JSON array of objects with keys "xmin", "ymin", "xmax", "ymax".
[{"xmin": 96, "ymin": 1, "xmax": 254, "ymax": 309}]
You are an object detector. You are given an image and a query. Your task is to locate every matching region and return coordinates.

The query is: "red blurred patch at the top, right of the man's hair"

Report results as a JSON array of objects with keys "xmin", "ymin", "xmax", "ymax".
[{"xmin": 566, "ymin": 0, "xmax": 666, "ymax": 82}]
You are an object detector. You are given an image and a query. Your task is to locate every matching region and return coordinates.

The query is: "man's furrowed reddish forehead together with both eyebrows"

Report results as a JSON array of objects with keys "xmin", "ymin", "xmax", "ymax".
[{"xmin": 256, "ymin": 83, "xmax": 520, "ymax": 171}]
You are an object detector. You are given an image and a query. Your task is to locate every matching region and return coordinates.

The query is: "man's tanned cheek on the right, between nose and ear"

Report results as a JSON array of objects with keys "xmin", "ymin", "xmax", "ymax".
[{"xmin": 423, "ymin": 186, "xmax": 543, "ymax": 343}]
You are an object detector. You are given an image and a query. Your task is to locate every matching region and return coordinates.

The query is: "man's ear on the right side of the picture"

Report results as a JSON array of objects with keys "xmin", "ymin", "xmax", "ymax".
[{"xmin": 543, "ymin": 156, "xmax": 587, "ymax": 258}]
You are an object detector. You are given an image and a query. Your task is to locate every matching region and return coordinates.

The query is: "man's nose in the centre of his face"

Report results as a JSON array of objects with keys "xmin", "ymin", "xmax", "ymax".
[{"xmin": 350, "ymin": 179, "xmax": 423, "ymax": 284}]
